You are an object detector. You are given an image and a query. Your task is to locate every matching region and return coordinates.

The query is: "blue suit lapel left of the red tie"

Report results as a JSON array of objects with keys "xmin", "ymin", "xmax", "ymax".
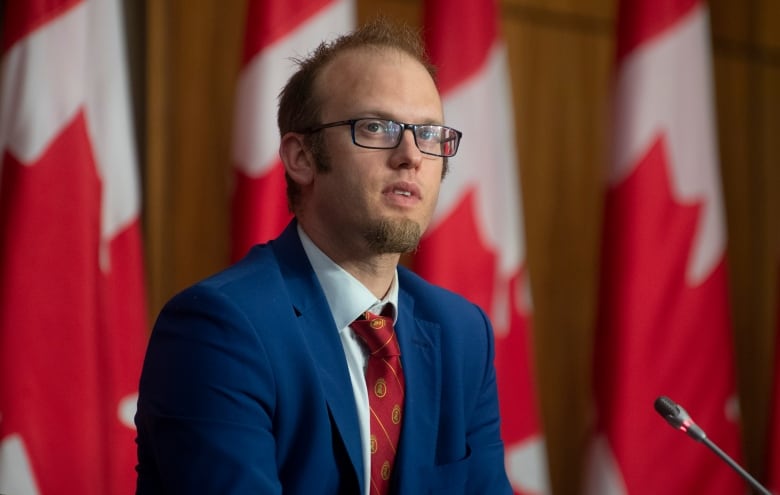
[{"xmin": 272, "ymin": 225, "xmax": 365, "ymax": 490}]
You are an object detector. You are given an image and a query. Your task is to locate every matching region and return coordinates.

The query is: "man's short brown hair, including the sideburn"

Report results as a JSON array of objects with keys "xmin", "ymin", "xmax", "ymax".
[{"xmin": 277, "ymin": 17, "xmax": 436, "ymax": 213}]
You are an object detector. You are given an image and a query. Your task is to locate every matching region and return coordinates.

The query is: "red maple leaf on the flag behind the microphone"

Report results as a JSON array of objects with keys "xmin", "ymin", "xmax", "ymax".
[{"xmin": 595, "ymin": 137, "xmax": 743, "ymax": 494}]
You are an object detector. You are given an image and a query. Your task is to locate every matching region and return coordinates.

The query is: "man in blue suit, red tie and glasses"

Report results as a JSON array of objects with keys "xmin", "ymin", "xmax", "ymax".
[{"xmin": 136, "ymin": 17, "xmax": 511, "ymax": 495}]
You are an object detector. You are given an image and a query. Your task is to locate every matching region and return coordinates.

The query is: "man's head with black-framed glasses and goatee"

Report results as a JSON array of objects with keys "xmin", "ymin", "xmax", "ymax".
[{"xmin": 278, "ymin": 16, "xmax": 460, "ymax": 253}]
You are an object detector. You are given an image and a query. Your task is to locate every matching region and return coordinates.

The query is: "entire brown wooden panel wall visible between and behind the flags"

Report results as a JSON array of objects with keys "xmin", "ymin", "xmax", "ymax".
[{"xmin": 143, "ymin": 0, "xmax": 780, "ymax": 495}]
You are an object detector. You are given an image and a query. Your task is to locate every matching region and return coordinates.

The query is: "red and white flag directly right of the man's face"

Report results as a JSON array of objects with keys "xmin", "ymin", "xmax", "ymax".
[{"xmin": 413, "ymin": 0, "xmax": 549, "ymax": 494}]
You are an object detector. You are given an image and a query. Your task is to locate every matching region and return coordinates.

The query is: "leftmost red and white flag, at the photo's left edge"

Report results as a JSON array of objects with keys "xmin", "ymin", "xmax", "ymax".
[{"xmin": 0, "ymin": 0, "xmax": 147, "ymax": 495}]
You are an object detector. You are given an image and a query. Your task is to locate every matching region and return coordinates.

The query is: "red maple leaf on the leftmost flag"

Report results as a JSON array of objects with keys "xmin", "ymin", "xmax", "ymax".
[{"xmin": 0, "ymin": 113, "xmax": 146, "ymax": 495}]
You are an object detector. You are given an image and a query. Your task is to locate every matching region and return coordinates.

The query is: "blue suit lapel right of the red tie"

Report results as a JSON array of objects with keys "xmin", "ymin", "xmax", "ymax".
[{"xmin": 395, "ymin": 290, "xmax": 442, "ymax": 493}]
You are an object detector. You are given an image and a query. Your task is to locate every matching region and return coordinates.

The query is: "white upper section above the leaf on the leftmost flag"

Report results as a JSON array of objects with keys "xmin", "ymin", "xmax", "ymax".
[{"xmin": 0, "ymin": 0, "xmax": 140, "ymax": 250}]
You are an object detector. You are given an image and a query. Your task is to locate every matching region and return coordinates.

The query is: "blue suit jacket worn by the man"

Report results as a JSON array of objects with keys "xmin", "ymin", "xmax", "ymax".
[{"xmin": 136, "ymin": 222, "xmax": 512, "ymax": 495}]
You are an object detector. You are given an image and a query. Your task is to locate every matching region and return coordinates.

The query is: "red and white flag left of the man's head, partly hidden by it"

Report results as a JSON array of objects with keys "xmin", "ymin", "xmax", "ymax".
[{"xmin": 231, "ymin": 0, "xmax": 355, "ymax": 261}]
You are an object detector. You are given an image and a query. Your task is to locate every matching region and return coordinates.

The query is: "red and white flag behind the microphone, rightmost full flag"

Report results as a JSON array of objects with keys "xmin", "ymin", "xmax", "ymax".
[{"xmin": 586, "ymin": 0, "xmax": 745, "ymax": 495}]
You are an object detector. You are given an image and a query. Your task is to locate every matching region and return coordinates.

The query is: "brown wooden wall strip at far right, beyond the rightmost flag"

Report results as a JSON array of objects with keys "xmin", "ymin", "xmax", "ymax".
[{"xmin": 711, "ymin": 0, "xmax": 780, "ymax": 484}]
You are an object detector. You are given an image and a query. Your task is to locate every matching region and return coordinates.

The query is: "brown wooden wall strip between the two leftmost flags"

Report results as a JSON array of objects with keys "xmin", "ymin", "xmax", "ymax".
[{"xmin": 144, "ymin": 0, "xmax": 245, "ymax": 317}]
